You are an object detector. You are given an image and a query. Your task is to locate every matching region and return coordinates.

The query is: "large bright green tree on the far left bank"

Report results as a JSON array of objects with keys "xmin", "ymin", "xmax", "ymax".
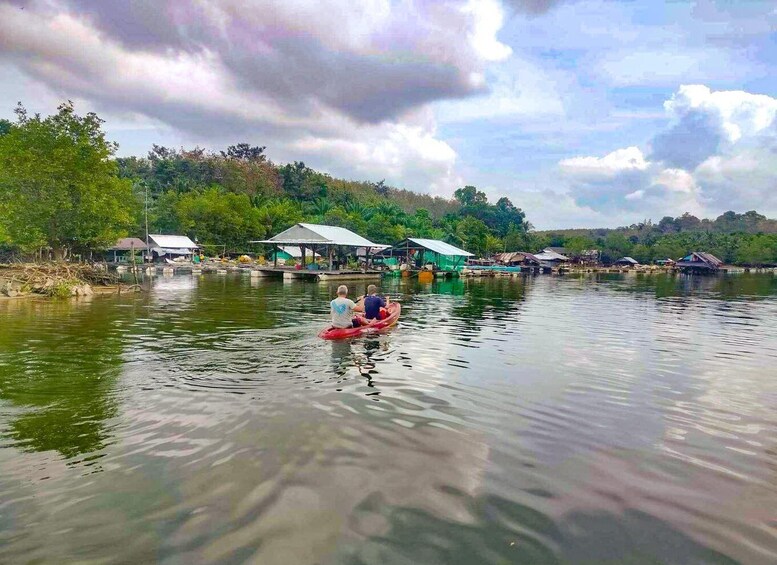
[{"xmin": 0, "ymin": 102, "xmax": 133, "ymax": 258}]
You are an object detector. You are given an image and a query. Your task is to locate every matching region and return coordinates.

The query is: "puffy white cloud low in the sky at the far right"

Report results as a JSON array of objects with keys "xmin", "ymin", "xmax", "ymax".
[{"xmin": 559, "ymin": 85, "xmax": 777, "ymax": 218}]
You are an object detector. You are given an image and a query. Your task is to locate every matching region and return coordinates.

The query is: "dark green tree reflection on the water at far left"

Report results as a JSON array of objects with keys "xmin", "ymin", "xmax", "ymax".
[{"xmin": 0, "ymin": 299, "xmax": 122, "ymax": 457}]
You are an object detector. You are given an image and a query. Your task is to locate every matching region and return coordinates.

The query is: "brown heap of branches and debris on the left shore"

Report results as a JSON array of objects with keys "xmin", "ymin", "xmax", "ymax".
[{"xmin": 0, "ymin": 263, "xmax": 119, "ymax": 298}]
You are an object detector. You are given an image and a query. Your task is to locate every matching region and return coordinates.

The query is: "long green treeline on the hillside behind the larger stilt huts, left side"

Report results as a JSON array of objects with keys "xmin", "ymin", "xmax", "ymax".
[{"xmin": 0, "ymin": 103, "xmax": 529, "ymax": 256}]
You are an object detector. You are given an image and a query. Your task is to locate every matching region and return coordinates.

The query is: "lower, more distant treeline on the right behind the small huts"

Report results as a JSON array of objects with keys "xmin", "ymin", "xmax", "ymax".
[{"xmin": 528, "ymin": 211, "xmax": 777, "ymax": 266}]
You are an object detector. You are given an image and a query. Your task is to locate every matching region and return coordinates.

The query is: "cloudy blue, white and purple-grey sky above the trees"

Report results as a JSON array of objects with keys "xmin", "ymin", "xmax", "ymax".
[{"xmin": 0, "ymin": 0, "xmax": 777, "ymax": 228}]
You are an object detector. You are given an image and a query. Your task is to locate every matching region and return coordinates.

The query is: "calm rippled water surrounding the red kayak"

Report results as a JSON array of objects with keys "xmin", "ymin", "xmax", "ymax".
[{"xmin": 0, "ymin": 275, "xmax": 777, "ymax": 564}]
